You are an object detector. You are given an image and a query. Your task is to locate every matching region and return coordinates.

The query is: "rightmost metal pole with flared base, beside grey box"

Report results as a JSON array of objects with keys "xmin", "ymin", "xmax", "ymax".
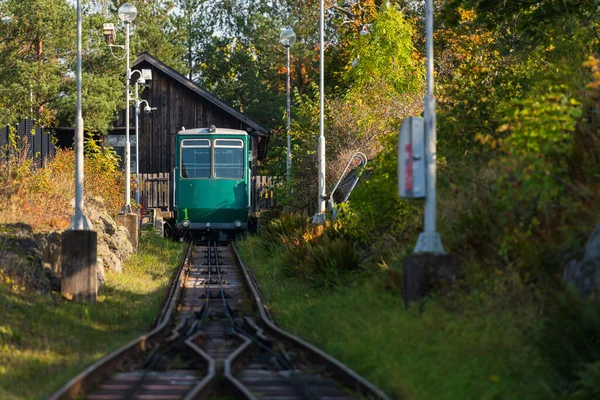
[{"xmin": 415, "ymin": 0, "xmax": 446, "ymax": 254}]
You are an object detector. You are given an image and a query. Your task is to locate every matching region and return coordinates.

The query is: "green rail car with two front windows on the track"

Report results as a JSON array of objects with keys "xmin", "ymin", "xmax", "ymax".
[{"xmin": 173, "ymin": 127, "xmax": 251, "ymax": 231}]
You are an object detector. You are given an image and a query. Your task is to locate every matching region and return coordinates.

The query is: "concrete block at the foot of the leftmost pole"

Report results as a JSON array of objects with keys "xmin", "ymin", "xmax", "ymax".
[{"xmin": 61, "ymin": 230, "xmax": 98, "ymax": 303}]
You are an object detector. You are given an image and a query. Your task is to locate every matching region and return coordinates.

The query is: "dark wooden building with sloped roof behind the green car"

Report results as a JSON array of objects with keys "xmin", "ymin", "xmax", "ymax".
[{"xmin": 106, "ymin": 53, "xmax": 269, "ymax": 174}]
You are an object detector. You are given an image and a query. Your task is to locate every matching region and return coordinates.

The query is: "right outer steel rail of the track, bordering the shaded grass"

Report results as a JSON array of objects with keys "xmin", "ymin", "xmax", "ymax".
[{"xmin": 231, "ymin": 243, "xmax": 390, "ymax": 400}]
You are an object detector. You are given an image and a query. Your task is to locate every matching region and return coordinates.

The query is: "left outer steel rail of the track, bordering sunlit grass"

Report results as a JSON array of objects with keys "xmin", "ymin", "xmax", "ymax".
[{"xmin": 49, "ymin": 244, "xmax": 203, "ymax": 400}]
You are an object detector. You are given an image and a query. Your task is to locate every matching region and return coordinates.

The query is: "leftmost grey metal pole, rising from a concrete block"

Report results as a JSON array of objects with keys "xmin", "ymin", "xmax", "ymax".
[{"xmin": 70, "ymin": 0, "xmax": 90, "ymax": 230}]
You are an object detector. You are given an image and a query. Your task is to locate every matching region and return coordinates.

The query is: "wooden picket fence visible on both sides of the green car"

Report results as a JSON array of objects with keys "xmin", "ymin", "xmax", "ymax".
[{"xmin": 139, "ymin": 173, "xmax": 277, "ymax": 212}]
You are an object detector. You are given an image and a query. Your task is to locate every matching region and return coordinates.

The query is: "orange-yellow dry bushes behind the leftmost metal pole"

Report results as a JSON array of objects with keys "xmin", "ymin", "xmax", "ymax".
[{"xmin": 0, "ymin": 133, "xmax": 125, "ymax": 230}]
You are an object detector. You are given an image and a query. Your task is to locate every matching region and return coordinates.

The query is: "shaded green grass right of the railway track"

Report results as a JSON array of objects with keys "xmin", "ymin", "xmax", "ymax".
[{"xmin": 239, "ymin": 237, "xmax": 553, "ymax": 400}]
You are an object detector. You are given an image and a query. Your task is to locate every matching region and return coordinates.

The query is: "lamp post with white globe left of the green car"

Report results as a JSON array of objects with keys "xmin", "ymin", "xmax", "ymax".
[{"xmin": 118, "ymin": 3, "xmax": 137, "ymax": 214}]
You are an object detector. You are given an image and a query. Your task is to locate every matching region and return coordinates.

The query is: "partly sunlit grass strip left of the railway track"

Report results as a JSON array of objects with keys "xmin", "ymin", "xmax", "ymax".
[{"xmin": 0, "ymin": 235, "xmax": 183, "ymax": 399}]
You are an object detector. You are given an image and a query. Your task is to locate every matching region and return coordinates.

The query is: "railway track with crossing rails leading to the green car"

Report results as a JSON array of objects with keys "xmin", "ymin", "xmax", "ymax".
[{"xmin": 50, "ymin": 242, "xmax": 387, "ymax": 400}]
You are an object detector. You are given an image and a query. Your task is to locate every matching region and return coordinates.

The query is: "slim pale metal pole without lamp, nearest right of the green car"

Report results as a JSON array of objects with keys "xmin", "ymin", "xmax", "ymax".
[{"xmin": 317, "ymin": 0, "xmax": 326, "ymax": 222}]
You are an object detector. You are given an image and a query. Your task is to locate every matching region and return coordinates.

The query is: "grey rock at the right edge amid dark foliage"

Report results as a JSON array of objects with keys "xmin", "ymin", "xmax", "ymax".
[{"xmin": 563, "ymin": 223, "xmax": 600, "ymax": 300}]
